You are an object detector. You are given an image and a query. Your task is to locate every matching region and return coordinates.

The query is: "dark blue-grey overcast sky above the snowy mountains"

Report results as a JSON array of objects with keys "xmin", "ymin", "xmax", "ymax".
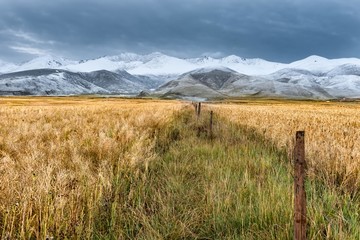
[{"xmin": 0, "ymin": 0, "xmax": 360, "ymax": 62}]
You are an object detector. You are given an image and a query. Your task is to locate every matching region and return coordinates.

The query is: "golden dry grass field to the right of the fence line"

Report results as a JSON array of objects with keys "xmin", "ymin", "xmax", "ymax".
[{"xmin": 211, "ymin": 101, "xmax": 360, "ymax": 193}]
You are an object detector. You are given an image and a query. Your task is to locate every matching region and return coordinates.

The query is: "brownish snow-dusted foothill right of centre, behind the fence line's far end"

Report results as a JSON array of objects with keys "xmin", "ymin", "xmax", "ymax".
[{"xmin": 155, "ymin": 69, "xmax": 333, "ymax": 99}]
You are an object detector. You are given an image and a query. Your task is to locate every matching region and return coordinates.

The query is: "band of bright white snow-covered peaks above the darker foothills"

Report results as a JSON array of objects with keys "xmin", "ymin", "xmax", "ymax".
[{"xmin": 0, "ymin": 52, "xmax": 360, "ymax": 78}]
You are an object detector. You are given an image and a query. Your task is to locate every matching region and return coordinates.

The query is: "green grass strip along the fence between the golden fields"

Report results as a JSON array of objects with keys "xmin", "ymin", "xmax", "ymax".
[{"xmin": 90, "ymin": 110, "xmax": 360, "ymax": 239}]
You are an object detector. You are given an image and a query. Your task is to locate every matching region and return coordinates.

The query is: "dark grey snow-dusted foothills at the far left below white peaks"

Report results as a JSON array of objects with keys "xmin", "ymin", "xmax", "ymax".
[{"xmin": 0, "ymin": 69, "xmax": 159, "ymax": 95}]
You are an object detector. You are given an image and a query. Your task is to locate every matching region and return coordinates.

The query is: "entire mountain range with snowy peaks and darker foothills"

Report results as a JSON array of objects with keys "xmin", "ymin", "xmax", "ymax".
[{"xmin": 0, "ymin": 52, "xmax": 360, "ymax": 99}]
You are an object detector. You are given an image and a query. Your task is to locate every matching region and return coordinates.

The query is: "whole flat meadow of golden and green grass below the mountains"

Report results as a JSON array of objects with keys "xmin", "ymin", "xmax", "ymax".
[{"xmin": 0, "ymin": 97, "xmax": 360, "ymax": 239}]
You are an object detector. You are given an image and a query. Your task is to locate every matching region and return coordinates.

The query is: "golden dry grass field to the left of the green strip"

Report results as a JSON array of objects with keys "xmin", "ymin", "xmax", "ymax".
[{"xmin": 0, "ymin": 98, "xmax": 181, "ymax": 239}]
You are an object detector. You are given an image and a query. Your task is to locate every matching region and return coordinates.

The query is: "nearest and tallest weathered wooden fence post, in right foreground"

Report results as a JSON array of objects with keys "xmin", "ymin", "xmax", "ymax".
[{"xmin": 294, "ymin": 131, "xmax": 306, "ymax": 240}]
